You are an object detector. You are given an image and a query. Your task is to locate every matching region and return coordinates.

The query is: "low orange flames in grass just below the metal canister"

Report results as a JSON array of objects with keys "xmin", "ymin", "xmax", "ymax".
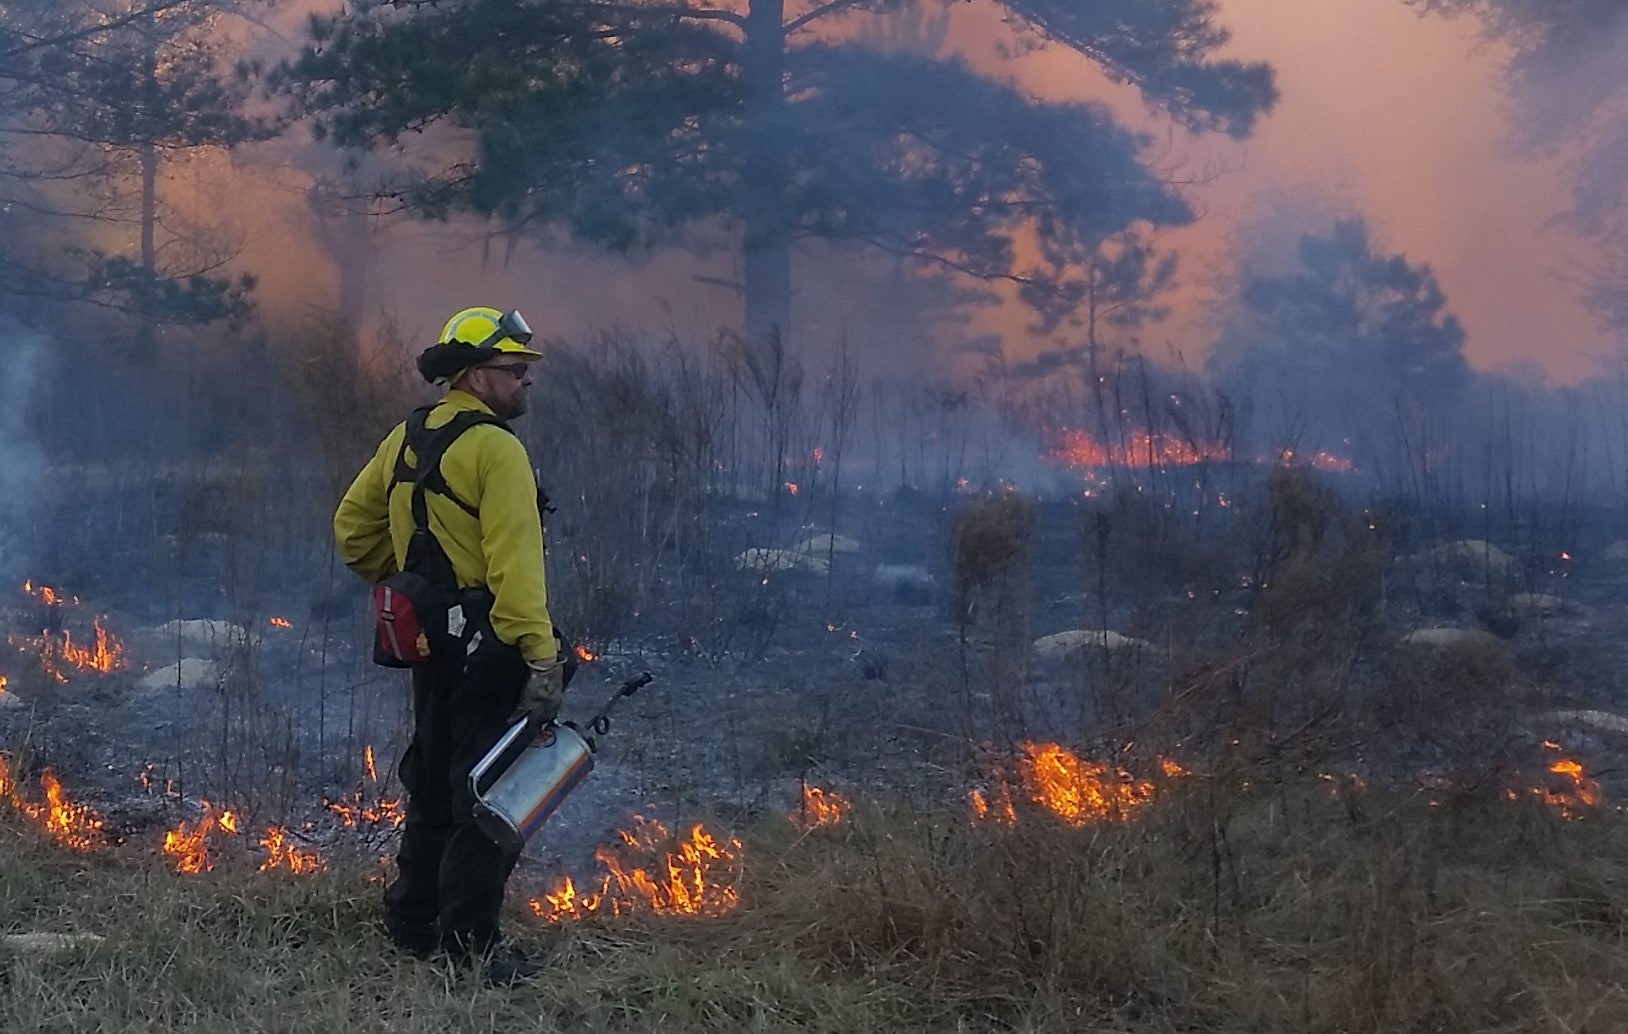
[{"xmin": 531, "ymin": 816, "xmax": 741, "ymax": 923}]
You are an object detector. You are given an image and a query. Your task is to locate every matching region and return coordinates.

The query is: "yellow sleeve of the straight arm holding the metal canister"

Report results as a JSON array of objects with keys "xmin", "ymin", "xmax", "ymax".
[{"xmin": 477, "ymin": 428, "xmax": 558, "ymax": 661}]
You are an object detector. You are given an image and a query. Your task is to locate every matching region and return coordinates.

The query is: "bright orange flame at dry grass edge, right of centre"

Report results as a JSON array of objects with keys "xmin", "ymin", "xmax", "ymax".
[{"xmin": 967, "ymin": 743, "xmax": 1185, "ymax": 827}]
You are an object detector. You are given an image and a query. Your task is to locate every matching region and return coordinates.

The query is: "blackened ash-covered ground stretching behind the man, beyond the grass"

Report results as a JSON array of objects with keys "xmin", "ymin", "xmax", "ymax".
[{"xmin": 0, "ymin": 474, "xmax": 1628, "ymax": 892}]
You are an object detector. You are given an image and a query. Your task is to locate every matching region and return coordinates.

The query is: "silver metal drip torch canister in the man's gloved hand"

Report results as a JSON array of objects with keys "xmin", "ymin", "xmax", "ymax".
[{"xmin": 469, "ymin": 718, "xmax": 594, "ymax": 848}]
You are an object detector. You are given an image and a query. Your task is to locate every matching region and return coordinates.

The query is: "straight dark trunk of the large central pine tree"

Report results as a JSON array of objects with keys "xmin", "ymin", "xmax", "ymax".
[{"xmin": 742, "ymin": 0, "xmax": 791, "ymax": 344}]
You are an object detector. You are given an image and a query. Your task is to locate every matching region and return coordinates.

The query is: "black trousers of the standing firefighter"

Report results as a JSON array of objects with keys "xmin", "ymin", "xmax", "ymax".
[{"xmin": 384, "ymin": 632, "xmax": 527, "ymax": 957}]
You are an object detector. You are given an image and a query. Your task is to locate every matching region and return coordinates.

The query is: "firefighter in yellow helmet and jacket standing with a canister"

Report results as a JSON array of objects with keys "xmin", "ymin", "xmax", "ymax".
[{"xmin": 334, "ymin": 308, "xmax": 565, "ymax": 984}]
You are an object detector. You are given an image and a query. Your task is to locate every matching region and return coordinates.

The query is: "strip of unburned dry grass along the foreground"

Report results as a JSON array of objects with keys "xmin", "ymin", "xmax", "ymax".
[{"xmin": 0, "ymin": 777, "xmax": 1628, "ymax": 1034}]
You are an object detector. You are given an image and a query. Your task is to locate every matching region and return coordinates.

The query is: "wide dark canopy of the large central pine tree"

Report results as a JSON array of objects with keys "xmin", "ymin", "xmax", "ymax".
[{"xmin": 280, "ymin": 0, "xmax": 1276, "ymax": 343}]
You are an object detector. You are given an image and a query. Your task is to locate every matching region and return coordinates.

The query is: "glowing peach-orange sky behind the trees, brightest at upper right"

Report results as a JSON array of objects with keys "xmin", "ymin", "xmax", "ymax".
[{"xmin": 246, "ymin": 0, "xmax": 1613, "ymax": 383}]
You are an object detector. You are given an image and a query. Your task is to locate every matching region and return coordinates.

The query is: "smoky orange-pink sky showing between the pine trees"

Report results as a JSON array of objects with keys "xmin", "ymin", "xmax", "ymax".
[{"xmin": 241, "ymin": 0, "xmax": 1620, "ymax": 383}]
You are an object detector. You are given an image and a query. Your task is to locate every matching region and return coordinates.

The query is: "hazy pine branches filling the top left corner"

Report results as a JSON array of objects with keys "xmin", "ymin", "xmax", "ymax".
[{"xmin": 0, "ymin": 0, "xmax": 264, "ymax": 322}]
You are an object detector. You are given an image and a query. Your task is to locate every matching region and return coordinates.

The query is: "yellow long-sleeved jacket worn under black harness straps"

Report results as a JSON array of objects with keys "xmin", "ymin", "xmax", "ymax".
[{"xmin": 334, "ymin": 389, "xmax": 557, "ymax": 661}]
